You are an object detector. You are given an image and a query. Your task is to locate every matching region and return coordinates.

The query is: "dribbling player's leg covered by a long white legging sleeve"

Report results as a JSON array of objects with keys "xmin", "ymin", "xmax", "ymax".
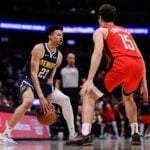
[{"xmin": 47, "ymin": 89, "xmax": 76, "ymax": 138}]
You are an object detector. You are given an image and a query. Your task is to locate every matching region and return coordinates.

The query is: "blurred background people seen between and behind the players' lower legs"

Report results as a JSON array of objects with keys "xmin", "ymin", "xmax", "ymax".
[{"xmin": 50, "ymin": 92, "xmax": 150, "ymax": 140}]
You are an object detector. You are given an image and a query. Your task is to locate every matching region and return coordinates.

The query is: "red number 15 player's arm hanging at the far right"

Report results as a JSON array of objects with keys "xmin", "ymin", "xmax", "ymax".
[{"xmin": 134, "ymin": 41, "xmax": 148, "ymax": 100}]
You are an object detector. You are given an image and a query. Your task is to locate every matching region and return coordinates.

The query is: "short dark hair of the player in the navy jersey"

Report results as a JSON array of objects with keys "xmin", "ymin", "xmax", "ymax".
[{"xmin": 46, "ymin": 24, "xmax": 63, "ymax": 36}]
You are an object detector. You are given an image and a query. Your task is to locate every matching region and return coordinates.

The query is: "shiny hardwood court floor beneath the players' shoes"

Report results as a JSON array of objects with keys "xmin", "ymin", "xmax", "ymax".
[{"xmin": 0, "ymin": 139, "xmax": 150, "ymax": 150}]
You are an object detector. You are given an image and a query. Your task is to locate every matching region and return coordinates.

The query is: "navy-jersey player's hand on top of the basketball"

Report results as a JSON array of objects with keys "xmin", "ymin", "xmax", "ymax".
[{"xmin": 40, "ymin": 97, "xmax": 50, "ymax": 114}]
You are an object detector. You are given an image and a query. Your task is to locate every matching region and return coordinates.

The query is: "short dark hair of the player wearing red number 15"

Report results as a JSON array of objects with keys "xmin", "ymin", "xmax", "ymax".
[{"xmin": 98, "ymin": 4, "xmax": 117, "ymax": 22}]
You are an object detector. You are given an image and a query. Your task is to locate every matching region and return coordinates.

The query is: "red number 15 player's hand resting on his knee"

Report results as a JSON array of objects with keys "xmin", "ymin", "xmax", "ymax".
[{"xmin": 80, "ymin": 80, "xmax": 93, "ymax": 96}]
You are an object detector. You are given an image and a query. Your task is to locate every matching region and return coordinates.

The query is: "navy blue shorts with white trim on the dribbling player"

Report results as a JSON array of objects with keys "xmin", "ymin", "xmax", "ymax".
[{"xmin": 18, "ymin": 76, "xmax": 54, "ymax": 98}]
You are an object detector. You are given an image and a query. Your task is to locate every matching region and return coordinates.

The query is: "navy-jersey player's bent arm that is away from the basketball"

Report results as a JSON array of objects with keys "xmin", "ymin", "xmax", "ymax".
[{"xmin": 48, "ymin": 52, "xmax": 63, "ymax": 84}]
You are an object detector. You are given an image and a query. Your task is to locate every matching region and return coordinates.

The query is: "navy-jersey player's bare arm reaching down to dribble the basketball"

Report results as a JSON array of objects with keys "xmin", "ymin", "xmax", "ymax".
[{"xmin": 30, "ymin": 44, "xmax": 48, "ymax": 110}]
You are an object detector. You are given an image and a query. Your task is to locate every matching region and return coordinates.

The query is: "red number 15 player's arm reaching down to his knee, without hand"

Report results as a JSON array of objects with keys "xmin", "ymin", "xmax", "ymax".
[{"xmin": 87, "ymin": 28, "xmax": 104, "ymax": 81}]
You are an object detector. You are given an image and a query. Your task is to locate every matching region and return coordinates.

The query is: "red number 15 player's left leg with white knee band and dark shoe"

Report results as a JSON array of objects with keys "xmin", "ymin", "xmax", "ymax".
[{"xmin": 67, "ymin": 85, "xmax": 103, "ymax": 145}]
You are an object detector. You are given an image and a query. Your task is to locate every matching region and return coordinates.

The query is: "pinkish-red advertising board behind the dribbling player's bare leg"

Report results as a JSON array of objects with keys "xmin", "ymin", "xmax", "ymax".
[{"xmin": 0, "ymin": 112, "xmax": 50, "ymax": 139}]
